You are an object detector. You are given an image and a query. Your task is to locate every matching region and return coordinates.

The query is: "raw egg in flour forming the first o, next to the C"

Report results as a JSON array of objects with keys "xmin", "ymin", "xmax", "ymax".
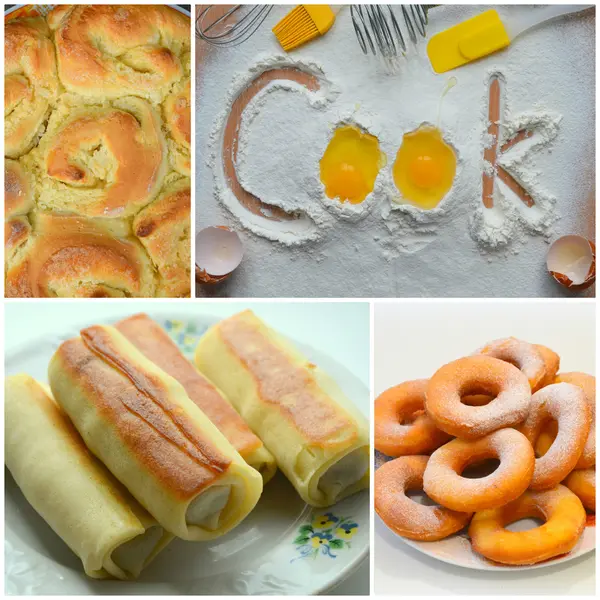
[{"xmin": 320, "ymin": 125, "xmax": 386, "ymax": 204}]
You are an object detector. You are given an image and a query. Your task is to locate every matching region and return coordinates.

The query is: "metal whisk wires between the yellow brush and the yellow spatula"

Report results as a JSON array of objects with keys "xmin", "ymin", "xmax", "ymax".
[{"xmin": 350, "ymin": 4, "xmax": 427, "ymax": 58}]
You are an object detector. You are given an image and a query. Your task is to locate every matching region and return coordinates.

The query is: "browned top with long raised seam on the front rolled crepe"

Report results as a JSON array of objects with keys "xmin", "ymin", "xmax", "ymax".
[{"xmin": 58, "ymin": 326, "xmax": 231, "ymax": 499}]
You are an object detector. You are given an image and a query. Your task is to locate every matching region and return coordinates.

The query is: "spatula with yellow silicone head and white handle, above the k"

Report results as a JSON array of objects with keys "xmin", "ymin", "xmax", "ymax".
[{"xmin": 427, "ymin": 4, "xmax": 592, "ymax": 73}]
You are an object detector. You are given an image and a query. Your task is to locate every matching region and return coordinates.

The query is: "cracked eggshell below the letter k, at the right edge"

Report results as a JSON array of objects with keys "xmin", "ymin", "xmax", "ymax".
[{"xmin": 546, "ymin": 235, "xmax": 596, "ymax": 290}]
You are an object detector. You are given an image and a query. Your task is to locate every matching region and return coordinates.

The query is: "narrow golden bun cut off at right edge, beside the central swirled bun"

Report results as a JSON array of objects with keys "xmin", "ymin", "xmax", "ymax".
[{"xmin": 163, "ymin": 77, "xmax": 192, "ymax": 177}]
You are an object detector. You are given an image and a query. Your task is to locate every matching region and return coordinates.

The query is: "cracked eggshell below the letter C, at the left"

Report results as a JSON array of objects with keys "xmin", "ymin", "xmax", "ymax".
[{"xmin": 196, "ymin": 225, "xmax": 244, "ymax": 283}]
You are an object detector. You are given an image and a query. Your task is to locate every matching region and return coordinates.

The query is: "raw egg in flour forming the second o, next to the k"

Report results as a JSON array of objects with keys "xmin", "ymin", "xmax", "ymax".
[{"xmin": 393, "ymin": 125, "xmax": 456, "ymax": 210}]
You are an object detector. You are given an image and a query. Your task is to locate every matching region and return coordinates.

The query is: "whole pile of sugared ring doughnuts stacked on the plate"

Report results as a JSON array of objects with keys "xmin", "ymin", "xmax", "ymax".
[{"xmin": 375, "ymin": 338, "xmax": 596, "ymax": 565}]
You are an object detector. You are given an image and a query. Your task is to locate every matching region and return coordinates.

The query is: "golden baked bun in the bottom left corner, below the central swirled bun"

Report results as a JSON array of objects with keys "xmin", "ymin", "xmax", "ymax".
[{"xmin": 5, "ymin": 212, "xmax": 156, "ymax": 298}]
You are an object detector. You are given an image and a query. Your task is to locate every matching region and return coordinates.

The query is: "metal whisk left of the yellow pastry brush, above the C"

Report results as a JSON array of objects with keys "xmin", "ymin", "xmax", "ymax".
[{"xmin": 196, "ymin": 4, "xmax": 273, "ymax": 47}]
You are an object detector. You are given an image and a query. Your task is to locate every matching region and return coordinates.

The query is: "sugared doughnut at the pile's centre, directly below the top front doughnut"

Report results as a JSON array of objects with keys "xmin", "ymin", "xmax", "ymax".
[{"xmin": 423, "ymin": 429, "xmax": 535, "ymax": 512}]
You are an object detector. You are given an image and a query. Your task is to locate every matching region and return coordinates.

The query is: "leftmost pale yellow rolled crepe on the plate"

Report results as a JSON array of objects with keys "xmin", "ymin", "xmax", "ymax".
[{"xmin": 4, "ymin": 375, "xmax": 173, "ymax": 579}]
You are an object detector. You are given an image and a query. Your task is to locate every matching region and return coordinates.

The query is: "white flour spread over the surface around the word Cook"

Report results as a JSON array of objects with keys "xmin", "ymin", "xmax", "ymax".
[{"xmin": 196, "ymin": 7, "xmax": 595, "ymax": 296}]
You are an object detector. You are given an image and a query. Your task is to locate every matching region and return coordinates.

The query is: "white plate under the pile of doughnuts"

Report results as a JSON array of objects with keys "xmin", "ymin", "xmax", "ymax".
[{"xmin": 375, "ymin": 451, "xmax": 596, "ymax": 571}]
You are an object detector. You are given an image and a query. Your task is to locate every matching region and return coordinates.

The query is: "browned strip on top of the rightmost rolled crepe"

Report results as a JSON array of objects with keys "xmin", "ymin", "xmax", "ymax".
[{"xmin": 218, "ymin": 312, "xmax": 358, "ymax": 447}]
